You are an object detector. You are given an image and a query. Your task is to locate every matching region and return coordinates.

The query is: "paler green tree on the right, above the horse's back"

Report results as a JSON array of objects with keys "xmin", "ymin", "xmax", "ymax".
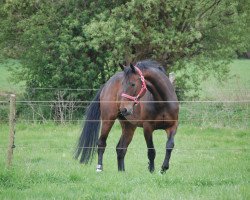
[{"xmin": 84, "ymin": 0, "xmax": 249, "ymax": 97}]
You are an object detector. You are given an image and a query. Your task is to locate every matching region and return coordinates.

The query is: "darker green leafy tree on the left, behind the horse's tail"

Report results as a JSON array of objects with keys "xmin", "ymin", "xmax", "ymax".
[{"xmin": 1, "ymin": 0, "xmax": 117, "ymax": 100}]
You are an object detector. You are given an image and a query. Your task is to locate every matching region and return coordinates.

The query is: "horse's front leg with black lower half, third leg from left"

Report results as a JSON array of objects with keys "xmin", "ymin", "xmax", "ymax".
[{"xmin": 143, "ymin": 126, "xmax": 155, "ymax": 173}]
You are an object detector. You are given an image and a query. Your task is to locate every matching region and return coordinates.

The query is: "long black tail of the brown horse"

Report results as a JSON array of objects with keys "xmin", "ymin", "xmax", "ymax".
[{"xmin": 74, "ymin": 89, "xmax": 102, "ymax": 164}]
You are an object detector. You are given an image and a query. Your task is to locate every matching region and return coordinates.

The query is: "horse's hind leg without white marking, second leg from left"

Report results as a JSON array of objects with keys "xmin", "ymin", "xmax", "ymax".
[{"xmin": 116, "ymin": 121, "xmax": 136, "ymax": 171}]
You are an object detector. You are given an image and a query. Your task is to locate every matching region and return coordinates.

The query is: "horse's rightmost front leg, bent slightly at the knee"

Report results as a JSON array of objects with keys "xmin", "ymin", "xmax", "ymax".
[{"xmin": 161, "ymin": 128, "xmax": 176, "ymax": 173}]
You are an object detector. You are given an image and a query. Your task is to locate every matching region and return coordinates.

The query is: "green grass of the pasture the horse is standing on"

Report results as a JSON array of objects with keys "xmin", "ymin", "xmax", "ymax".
[{"xmin": 0, "ymin": 123, "xmax": 250, "ymax": 199}]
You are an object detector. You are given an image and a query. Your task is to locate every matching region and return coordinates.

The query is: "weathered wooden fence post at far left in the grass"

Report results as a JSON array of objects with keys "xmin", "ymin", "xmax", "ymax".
[{"xmin": 7, "ymin": 94, "xmax": 16, "ymax": 167}]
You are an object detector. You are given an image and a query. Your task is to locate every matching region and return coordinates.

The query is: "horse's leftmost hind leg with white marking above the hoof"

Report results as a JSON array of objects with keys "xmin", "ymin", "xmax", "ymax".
[{"xmin": 96, "ymin": 120, "xmax": 115, "ymax": 172}]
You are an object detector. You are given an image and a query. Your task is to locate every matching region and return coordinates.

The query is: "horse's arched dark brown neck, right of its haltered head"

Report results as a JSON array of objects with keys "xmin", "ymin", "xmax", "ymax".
[{"xmin": 144, "ymin": 69, "xmax": 177, "ymax": 101}]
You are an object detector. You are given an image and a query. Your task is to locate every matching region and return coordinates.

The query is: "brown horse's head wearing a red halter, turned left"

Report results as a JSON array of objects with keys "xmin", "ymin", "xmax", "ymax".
[{"xmin": 120, "ymin": 64, "xmax": 147, "ymax": 116}]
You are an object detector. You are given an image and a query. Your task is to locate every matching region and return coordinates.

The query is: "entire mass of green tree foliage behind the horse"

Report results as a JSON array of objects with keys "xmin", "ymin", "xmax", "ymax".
[{"xmin": 0, "ymin": 0, "xmax": 250, "ymax": 103}]
